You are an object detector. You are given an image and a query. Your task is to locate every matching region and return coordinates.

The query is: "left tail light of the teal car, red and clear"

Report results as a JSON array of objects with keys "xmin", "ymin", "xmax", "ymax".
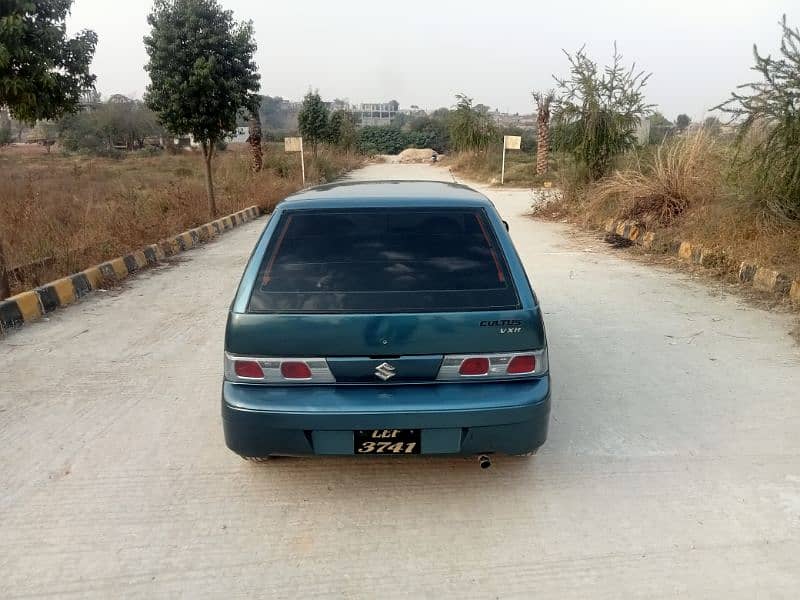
[{"xmin": 225, "ymin": 352, "xmax": 336, "ymax": 384}]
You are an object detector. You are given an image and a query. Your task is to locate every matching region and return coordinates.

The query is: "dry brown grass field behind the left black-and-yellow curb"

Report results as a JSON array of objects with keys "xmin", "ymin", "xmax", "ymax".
[{"xmin": 0, "ymin": 146, "xmax": 361, "ymax": 293}]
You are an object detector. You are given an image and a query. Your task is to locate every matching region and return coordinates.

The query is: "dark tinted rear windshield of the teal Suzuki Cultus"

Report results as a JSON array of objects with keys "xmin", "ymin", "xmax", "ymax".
[{"xmin": 249, "ymin": 208, "xmax": 518, "ymax": 313}]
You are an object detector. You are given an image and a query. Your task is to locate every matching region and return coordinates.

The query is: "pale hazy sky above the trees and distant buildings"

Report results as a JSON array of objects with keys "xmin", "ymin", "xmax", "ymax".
[{"xmin": 69, "ymin": 0, "xmax": 800, "ymax": 119}]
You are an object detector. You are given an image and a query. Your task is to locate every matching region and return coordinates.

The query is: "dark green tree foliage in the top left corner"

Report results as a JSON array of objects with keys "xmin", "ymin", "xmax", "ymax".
[{"xmin": 0, "ymin": 0, "xmax": 97, "ymax": 123}]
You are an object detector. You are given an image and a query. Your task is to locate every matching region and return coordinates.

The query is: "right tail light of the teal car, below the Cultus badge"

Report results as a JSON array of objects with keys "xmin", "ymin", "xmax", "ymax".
[{"xmin": 436, "ymin": 348, "xmax": 549, "ymax": 381}]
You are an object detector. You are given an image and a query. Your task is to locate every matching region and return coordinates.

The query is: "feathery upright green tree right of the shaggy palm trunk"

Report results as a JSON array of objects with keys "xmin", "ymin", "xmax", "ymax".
[{"xmin": 555, "ymin": 44, "xmax": 652, "ymax": 179}]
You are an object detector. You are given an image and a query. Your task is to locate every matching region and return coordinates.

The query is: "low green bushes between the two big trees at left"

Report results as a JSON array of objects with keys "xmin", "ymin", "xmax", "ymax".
[{"xmin": 57, "ymin": 96, "xmax": 163, "ymax": 155}]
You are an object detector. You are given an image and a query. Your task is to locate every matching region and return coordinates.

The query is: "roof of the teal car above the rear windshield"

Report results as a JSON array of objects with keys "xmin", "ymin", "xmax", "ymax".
[{"xmin": 280, "ymin": 180, "xmax": 492, "ymax": 209}]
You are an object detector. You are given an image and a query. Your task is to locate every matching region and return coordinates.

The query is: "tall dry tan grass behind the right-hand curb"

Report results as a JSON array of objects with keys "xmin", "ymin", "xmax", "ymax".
[{"xmin": 550, "ymin": 132, "xmax": 800, "ymax": 277}]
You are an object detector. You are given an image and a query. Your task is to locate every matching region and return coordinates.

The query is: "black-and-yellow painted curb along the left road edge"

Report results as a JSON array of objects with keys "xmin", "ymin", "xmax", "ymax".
[{"xmin": 0, "ymin": 206, "xmax": 262, "ymax": 335}]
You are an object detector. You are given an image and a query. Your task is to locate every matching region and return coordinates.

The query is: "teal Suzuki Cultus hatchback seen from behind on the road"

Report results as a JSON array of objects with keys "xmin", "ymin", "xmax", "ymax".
[{"xmin": 222, "ymin": 181, "xmax": 550, "ymax": 466}]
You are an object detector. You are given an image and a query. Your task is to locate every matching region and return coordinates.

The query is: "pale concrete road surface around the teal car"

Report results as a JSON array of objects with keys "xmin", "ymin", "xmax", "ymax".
[{"xmin": 0, "ymin": 165, "xmax": 800, "ymax": 599}]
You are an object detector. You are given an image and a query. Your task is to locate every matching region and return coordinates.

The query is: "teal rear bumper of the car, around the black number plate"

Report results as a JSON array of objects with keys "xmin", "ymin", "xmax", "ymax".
[{"xmin": 222, "ymin": 376, "xmax": 550, "ymax": 456}]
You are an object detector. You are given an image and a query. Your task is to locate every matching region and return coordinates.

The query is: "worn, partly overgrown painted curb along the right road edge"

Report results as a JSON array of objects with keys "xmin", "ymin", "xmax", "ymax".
[{"xmin": 604, "ymin": 218, "xmax": 800, "ymax": 308}]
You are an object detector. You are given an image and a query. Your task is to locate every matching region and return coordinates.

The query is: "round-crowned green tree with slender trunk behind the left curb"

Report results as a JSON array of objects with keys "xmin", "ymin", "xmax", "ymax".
[{"xmin": 144, "ymin": 0, "xmax": 260, "ymax": 216}]
